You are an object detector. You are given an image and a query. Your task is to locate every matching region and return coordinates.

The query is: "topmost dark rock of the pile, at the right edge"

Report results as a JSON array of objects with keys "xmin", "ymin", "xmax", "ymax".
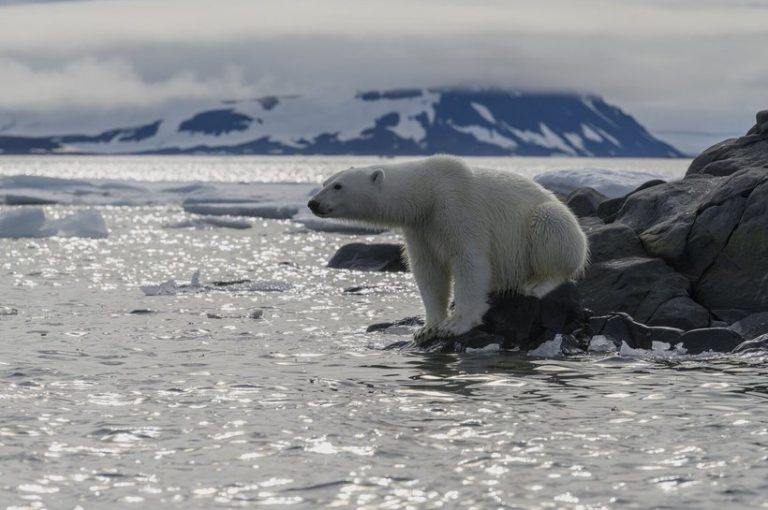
[{"xmin": 685, "ymin": 110, "xmax": 768, "ymax": 178}]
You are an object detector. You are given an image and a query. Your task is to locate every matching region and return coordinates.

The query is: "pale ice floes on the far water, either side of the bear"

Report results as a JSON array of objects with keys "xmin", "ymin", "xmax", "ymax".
[{"xmin": 0, "ymin": 168, "xmax": 684, "ymax": 237}]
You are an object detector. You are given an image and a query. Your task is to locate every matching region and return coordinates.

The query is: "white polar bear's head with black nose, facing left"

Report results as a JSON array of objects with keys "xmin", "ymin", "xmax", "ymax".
[{"xmin": 307, "ymin": 166, "xmax": 384, "ymax": 221}]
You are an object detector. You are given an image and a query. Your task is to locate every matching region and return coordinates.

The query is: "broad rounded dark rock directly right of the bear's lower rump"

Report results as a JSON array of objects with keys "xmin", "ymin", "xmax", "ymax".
[{"xmin": 577, "ymin": 257, "xmax": 690, "ymax": 322}]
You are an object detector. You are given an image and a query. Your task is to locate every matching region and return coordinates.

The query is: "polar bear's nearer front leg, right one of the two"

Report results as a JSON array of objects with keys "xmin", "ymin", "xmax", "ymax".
[{"xmin": 437, "ymin": 249, "xmax": 491, "ymax": 337}]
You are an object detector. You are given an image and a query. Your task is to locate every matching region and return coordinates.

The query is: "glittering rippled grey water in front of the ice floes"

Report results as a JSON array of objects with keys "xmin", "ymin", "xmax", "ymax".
[{"xmin": 0, "ymin": 157, "xmax": 768, "ymax": 509}]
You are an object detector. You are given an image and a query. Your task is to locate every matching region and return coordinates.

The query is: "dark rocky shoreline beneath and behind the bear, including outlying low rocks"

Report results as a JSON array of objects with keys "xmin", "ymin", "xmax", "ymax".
[{"xmin": 332, "ymin": 110, "xmax": 768, "ymax": 353}]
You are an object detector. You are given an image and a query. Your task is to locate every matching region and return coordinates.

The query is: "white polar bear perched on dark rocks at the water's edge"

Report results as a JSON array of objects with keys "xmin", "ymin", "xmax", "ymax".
[{"xmin": 308, "ymin": 156, "xmax": 588, "ymax": 343}]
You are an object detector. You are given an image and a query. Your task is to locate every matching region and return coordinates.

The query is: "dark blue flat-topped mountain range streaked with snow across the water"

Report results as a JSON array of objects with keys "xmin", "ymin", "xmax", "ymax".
[{"xmin": 0, "ymin": 88, "xmax": 682, "ymax": 157}]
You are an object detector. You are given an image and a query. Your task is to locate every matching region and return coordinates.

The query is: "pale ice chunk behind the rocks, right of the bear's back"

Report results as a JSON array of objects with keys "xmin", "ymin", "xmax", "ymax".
[{"xmin": 534, "ymin": 168, "xmax": 669, "ymax": 198}]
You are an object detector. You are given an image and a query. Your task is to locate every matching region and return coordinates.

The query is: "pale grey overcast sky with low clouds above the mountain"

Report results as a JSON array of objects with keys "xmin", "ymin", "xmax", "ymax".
[{"xmin": 0, "ymin": 0, "xmax": 768, "ymax": 150}]
